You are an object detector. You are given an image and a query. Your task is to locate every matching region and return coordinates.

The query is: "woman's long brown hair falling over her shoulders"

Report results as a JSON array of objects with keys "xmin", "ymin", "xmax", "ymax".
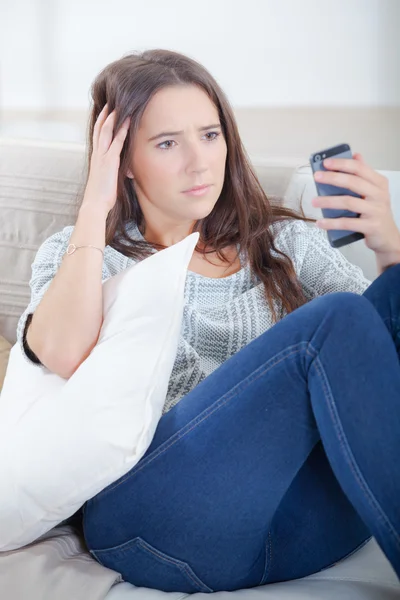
[{"xmin": 86, "ymin": 49, "xmax": 315, "ymax": 321}]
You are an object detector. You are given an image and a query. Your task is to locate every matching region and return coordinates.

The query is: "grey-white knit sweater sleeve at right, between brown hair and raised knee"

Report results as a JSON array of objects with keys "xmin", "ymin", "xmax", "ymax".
[{"xmin": 272, "ymin": 220, "xmax": 371, "ymax": 300}]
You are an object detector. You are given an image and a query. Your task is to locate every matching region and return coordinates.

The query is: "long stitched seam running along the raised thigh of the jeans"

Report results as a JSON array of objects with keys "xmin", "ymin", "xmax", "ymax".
[{"xmin": 92, "ymin": 342, "xmax": 309, "ymax": 502}]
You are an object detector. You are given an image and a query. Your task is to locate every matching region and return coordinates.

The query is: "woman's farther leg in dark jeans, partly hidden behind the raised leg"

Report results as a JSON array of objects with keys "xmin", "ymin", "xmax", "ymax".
[{"xmin": 265, "ymin": 265, "xmax": 400, "ymax": 583}]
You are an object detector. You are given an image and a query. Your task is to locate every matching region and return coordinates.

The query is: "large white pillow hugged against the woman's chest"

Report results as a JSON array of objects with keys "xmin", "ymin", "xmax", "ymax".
[{"xmin": 0, "ymin": 232, "xmax": 199, "ymax": 551}]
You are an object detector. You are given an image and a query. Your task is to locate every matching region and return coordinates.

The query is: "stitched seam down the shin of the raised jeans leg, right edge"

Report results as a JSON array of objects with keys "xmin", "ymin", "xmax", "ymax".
[{"xmin": 307, "ymin": 342, "xmax": 400, "ymax": 547}]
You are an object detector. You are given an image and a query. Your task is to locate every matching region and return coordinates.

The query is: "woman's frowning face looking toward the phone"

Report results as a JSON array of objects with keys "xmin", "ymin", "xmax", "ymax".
[{"xmin": 128, "ymin": 86, "xmax": 227, "ymax": 230}]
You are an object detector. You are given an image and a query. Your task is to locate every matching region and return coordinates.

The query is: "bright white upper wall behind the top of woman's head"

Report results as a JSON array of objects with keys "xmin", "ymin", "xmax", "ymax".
[{"xmin": 0, "ymin": 0, "xmax": 400, "ymax": 110}]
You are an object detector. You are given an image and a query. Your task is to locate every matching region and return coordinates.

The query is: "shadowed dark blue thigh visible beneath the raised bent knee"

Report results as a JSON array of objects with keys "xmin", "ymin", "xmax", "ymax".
[{"xmin": 260, "ymin": 441, "xmax": 371, "ymax": 584}]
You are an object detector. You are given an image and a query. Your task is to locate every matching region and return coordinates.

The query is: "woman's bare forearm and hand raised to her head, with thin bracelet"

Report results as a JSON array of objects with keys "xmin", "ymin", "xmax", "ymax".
[{"xmin": 22, "ymin": 104, "xmax": 130, "ymax": 378}]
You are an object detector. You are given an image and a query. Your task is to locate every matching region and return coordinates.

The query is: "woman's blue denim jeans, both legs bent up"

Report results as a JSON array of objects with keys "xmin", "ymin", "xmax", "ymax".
[{"xmin": 83, "ymin": 265, "xmax": 400, "ymax": 593}]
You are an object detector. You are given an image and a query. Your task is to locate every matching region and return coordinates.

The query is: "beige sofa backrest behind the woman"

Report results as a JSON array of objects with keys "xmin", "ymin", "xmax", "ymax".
[{"xmin": 0, "ymin": 138, "xmax": 294, "ymax": 343}]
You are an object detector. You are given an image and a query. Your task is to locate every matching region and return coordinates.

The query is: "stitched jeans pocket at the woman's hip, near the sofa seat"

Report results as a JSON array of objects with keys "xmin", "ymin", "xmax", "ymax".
[{"xmin": 90, "ymin": 537, "xmax": 214, "ymax": 594}]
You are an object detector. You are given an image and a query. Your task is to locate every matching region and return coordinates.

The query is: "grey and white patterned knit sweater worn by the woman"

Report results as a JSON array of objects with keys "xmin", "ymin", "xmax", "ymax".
[{"xmin": 17, "ymin": 220, "xmax": 371, "ymax": 414}]
